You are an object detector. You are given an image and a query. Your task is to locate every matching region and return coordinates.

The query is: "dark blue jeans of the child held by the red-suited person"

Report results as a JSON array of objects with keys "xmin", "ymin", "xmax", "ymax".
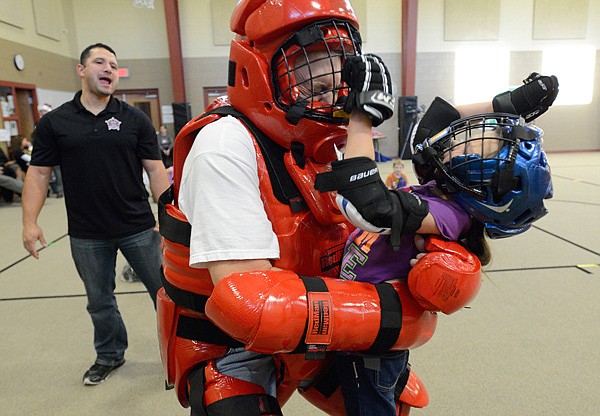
[{"xmin": 336, "ymin": 351, "xmax": 408, "ymax": 416}]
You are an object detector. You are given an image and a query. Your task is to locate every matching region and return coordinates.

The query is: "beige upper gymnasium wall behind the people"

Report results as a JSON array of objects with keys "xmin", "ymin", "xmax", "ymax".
[{"xmin": 0, "ymin": 0, "xmax": 600, "ymax": 156}]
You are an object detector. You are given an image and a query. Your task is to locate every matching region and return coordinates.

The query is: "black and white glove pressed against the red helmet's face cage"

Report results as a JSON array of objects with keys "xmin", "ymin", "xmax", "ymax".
[{"xmin": 342, "ymin": 54, "xmax": 396, "ymax": 127}]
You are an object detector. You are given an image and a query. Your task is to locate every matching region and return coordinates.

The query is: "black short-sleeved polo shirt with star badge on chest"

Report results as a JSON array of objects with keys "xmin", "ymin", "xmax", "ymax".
[{"xmin": 30, "ymin": 91, "xmax": 161, "ymax": 239}]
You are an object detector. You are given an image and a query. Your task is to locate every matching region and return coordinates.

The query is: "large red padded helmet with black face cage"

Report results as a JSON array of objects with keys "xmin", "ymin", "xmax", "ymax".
[{"xmin": 227, "ymin": 0, "xmax": 361, "ymax": 163}]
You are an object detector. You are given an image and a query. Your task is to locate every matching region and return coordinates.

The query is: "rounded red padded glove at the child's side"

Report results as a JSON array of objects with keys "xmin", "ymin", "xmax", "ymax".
[{"xmin": 408, "ymin": 236, "xmax": 481, "ymax": 315}]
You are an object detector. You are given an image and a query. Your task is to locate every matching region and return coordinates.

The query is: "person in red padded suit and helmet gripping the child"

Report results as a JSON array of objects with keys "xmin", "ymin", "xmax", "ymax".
[{"xmin": 157, "ymin": 0, "xmax": 556, "ymax": 416}]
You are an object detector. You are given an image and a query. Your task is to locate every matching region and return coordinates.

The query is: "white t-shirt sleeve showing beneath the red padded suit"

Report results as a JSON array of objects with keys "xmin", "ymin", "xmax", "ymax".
[{"xmin": 179, "ymin": 116, "xmax": 279, "ymax": 267}]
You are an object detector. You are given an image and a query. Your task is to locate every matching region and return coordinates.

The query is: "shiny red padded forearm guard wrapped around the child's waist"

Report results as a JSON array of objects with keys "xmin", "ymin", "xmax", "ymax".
[{"xmin": 205, "ymin": 270, "xmax": 437, "ymax": 353}]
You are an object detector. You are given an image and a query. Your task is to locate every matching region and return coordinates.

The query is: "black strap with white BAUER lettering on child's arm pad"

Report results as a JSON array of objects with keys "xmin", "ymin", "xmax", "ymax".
[{"xmin": 315, "ymin": 157, "xmax": 381, "ymax": 192}]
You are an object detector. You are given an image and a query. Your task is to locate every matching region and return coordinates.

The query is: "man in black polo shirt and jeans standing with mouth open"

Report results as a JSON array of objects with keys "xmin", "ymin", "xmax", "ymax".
[{"xmin": 22, "ymin": 43, "xmax": 169, "ymax": 385}]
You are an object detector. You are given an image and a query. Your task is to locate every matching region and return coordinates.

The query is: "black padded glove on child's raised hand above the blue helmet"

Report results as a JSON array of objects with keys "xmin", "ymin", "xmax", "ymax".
[{"xmin": 492, "ymin": 72, "xmax": 558, "ymax": 122}]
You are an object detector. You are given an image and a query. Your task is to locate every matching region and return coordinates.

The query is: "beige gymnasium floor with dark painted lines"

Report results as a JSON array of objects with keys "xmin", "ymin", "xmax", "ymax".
[{"xmin": 0, "ymin": 152, "xmax": 600, "ymax": 416}]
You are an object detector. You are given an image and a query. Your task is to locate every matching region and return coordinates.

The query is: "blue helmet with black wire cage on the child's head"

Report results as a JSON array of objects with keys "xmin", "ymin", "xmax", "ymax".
[{"xmin": 414, "ymin": 113, "xmax": 553, "ymax": 238}]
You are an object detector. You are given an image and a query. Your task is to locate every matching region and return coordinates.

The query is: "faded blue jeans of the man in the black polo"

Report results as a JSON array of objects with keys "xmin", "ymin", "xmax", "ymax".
[{"xmin": 70, "ymin": 229, "xmax": 162, "ymax": 365}]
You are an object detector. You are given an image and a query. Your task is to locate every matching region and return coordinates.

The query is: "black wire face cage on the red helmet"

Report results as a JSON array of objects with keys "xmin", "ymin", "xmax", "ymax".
[{"xmin": 271, "ymin": 20, "xmax": 361, "ymax": 124}]
